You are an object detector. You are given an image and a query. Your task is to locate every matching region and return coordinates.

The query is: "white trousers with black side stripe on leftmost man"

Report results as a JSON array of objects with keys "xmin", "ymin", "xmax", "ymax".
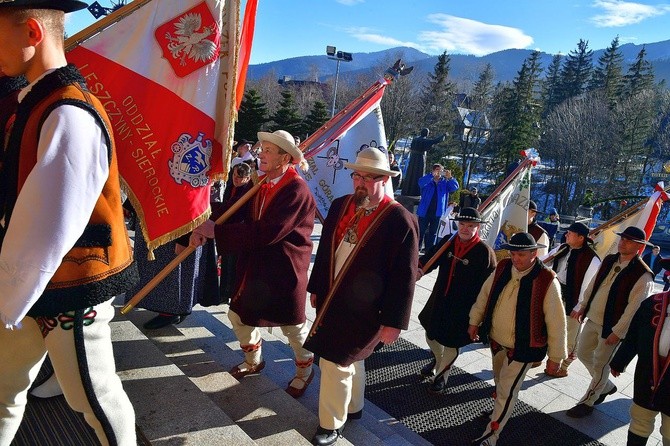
[{"xmin": 0, "ymin": 299, "xmax": 137, "ymax": 446}]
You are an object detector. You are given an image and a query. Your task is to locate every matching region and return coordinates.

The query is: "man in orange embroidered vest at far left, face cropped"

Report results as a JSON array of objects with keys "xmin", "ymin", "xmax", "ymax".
[{"xmin": 0, "ymin": 0, "xmax": 137, "ymax": 446}]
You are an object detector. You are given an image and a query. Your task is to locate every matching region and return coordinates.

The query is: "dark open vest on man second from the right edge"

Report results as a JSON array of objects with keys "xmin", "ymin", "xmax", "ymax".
[{"xmin": 584, "ymin": 254, "xmax": 651, "ymax": 338}]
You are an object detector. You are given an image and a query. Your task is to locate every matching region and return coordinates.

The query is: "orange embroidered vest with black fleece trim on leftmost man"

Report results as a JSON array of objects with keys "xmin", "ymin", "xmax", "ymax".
[{"xmin": 4, "ymin": 65, "xmax": 139, "ymax": 316}]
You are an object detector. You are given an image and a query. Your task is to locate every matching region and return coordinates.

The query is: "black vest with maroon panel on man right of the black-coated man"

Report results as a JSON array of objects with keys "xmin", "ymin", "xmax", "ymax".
[{"xmin": 479, "ymin": 259, "xmax": 555, "ymax": 362}]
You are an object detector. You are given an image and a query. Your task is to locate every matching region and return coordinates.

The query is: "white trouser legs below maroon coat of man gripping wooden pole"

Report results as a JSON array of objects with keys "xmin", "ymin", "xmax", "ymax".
[{"xmin": 228, "ymin": 310, "xmax": 314, "ymax": 378}]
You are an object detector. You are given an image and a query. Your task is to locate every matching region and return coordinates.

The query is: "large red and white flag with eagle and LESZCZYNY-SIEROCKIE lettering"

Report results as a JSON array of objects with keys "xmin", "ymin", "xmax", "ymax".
[{"xmin": 66, "ymin": 0, "xmax": 240, "ymax": 256}]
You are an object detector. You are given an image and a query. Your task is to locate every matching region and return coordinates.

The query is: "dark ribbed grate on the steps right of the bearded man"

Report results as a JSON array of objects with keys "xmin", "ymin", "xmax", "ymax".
[{"xmin": 365, "ymin": 338, "xmax": 602, "ymax": 446}]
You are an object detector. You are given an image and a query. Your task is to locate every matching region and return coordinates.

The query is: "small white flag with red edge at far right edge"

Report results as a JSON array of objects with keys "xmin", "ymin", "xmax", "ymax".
[{"xmin": 591, "ymin": 182, "xmax": 669, "ymax": 258}]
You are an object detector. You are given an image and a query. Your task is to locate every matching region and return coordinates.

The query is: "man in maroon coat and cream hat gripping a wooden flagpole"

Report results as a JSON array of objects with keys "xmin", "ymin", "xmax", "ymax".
[{"xmin": 191, "ymin": 130, "xmax": 316, "ymax": 398}]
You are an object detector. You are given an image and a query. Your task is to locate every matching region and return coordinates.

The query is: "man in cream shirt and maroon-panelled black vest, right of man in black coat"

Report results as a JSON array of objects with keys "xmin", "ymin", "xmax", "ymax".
[{"xmin": 468, "ymin": 232, "xmax": 567, "ymax": 446}]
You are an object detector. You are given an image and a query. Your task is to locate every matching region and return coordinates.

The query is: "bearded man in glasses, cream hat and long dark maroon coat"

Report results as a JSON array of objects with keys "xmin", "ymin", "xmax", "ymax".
[{"xmin": 305, "ymin": 148, "xmax": 419, "ymax": 445}]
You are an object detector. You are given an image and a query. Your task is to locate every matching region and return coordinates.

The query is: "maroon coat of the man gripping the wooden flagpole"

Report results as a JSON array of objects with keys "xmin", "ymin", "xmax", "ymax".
[{"xmin": 215, "ymin": 169, "xmax": 316, "ymax": 327}]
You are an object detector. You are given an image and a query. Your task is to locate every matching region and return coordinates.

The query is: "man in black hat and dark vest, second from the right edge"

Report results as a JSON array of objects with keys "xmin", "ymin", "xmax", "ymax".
[{"xmin": 566, "ymin": 226, "xmax": 654, "ymax": 418}]
